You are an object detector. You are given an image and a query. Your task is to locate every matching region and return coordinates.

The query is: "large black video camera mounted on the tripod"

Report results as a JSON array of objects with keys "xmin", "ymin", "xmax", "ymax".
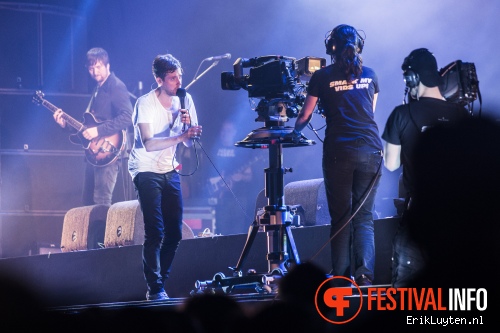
[{"xmin": 221, "ymin": 55, "xmax": 326, "ymax": 122}]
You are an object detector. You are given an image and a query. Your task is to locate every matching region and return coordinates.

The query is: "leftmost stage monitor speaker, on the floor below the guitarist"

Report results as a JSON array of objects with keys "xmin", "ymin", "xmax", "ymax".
[{"xmin": 61, "ymin": 205, "xmax": 109, "ymax": 252}]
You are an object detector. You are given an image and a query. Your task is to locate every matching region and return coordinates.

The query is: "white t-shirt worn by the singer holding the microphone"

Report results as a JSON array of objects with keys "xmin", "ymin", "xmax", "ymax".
[{"xmin": 128, "ymin": 90, "xmax": 198, "ymax": 179}]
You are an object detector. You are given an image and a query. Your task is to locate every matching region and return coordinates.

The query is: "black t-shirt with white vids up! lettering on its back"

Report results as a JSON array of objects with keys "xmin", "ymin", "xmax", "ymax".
[{"xmin": 308, "ymin": 64, "xmax": 382, "ymax": 150}]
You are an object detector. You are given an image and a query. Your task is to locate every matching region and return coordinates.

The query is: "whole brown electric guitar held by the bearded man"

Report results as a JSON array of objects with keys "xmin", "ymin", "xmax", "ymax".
[{"xmin": 33, "ymin": 90, "xmax": 127, "ymax": 167}]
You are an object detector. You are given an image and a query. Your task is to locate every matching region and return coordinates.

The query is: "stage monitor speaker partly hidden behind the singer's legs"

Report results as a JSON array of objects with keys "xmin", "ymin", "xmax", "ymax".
[{"xmin": 104, "ymin": 200, "xmax": 194, "ymax": 248}]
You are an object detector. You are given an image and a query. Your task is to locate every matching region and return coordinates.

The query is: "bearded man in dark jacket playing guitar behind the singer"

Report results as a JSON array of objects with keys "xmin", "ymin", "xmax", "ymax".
[{"xmin": 53, "ymin": 47, "xmax": 132, "ymax": 206}]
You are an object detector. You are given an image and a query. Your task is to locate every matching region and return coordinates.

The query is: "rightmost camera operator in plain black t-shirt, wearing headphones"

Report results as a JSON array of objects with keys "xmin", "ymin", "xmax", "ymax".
[{"xmin": 382, "ymin": 48, "xmax": 469, "ymax": 287}]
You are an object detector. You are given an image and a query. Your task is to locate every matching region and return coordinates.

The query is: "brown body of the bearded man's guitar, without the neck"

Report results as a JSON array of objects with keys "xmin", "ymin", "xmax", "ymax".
[{"xmin": 69, "ymin": 112, "xmax": 127, "ymax": 167}]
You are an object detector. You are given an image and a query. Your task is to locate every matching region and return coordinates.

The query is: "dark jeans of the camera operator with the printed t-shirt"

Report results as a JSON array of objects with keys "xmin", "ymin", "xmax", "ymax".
[{"xmin": 323, "ymin": 140, "xmax": 382, "ymax": 281}]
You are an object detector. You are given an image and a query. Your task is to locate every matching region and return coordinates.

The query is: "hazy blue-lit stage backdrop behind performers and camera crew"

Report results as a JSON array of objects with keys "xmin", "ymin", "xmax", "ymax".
[{"xmin": 0, "ymin": 0, "xmax": 500, "ymax": 254}]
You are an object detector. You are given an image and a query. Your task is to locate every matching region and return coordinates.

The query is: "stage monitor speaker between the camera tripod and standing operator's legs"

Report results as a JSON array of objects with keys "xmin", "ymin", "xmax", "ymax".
[{"xmin": 285, "ymin": 178, "xmax": 330, "ymax": 226}]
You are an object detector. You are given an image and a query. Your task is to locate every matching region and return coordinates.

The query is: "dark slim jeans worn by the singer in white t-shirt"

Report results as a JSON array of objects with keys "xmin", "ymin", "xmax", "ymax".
[{"xmin": 134, "ymin": 171, "xmax": 183, "ymax": 294}]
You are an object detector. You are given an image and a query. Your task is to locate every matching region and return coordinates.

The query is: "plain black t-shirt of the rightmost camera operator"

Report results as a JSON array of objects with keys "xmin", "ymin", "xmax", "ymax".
[{"xmin": 382, "ymin": 97, "xmax": 468, "ymax": 193}]
